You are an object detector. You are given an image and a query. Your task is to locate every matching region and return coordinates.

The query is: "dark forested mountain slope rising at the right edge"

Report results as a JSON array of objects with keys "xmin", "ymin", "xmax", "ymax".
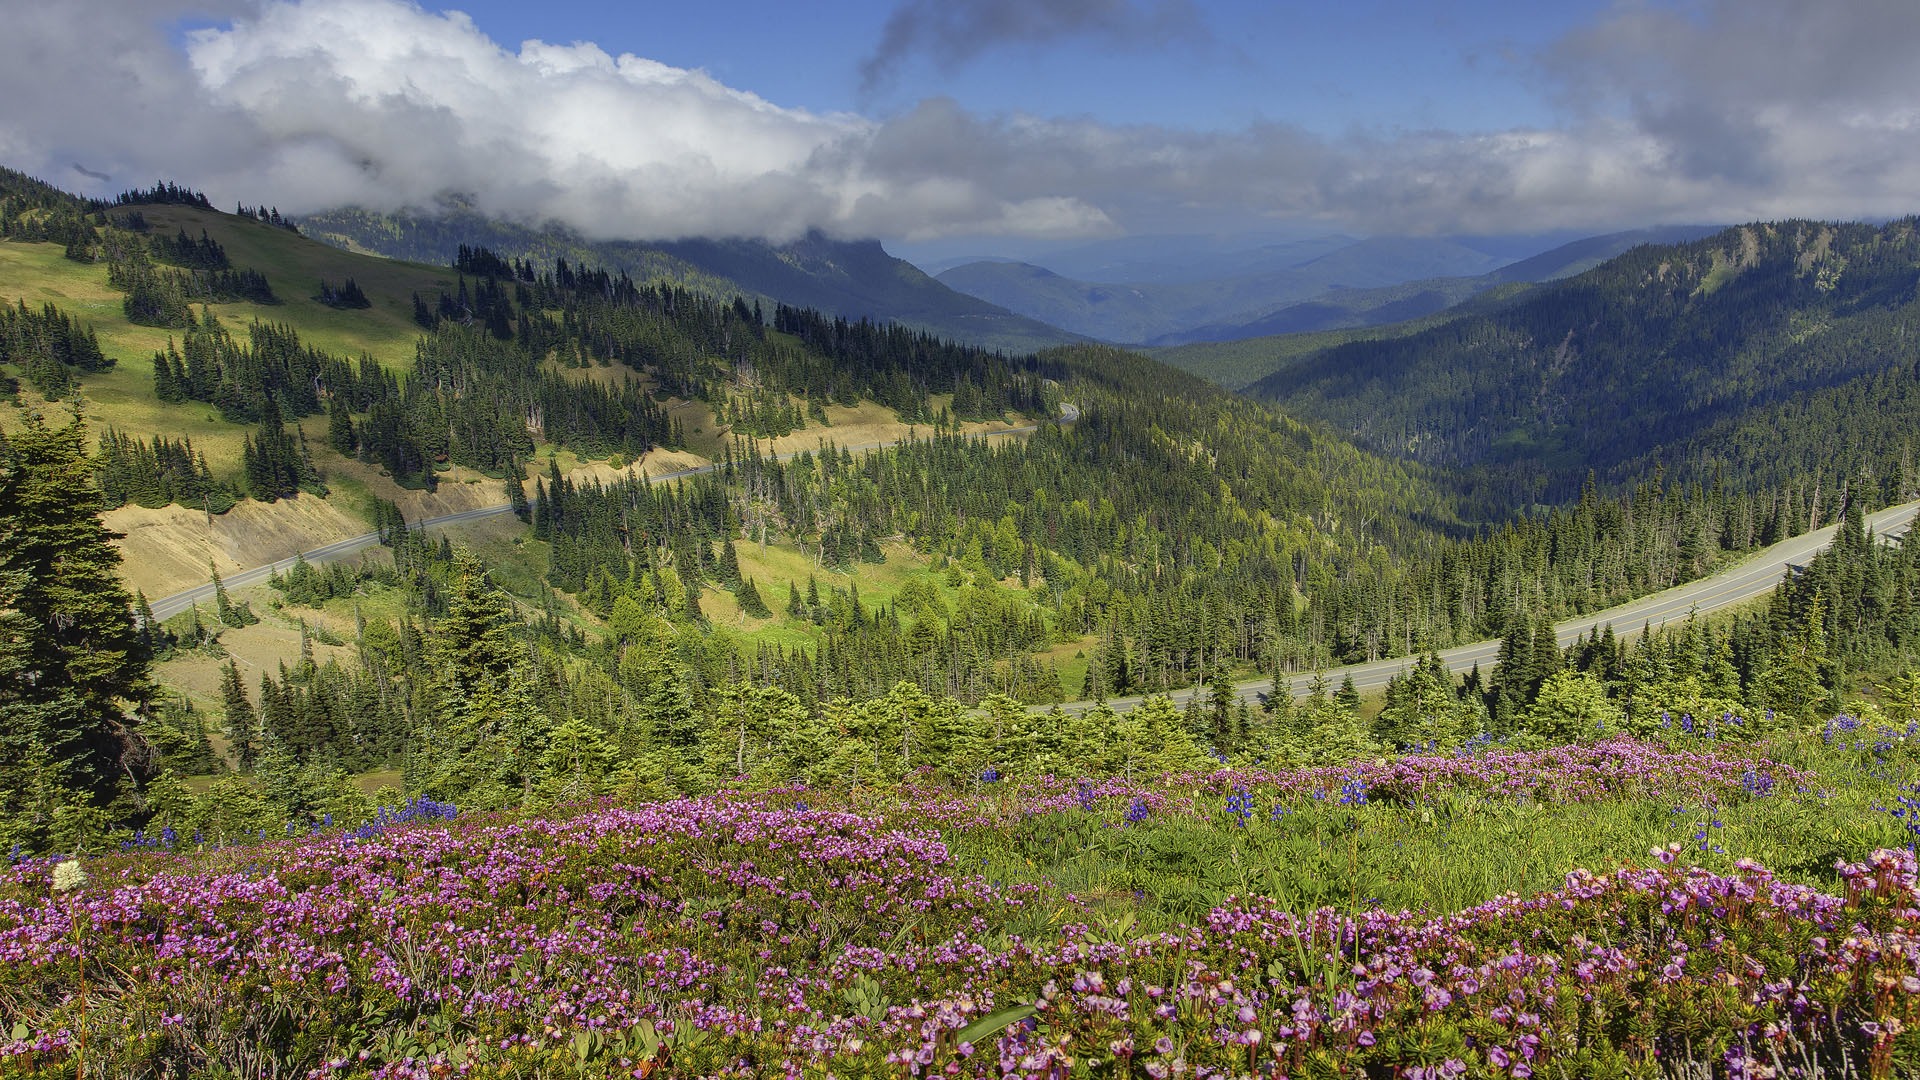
[{"xmin": 1252, "ymin": 219, "xmax": 1920, "ymax": 498}]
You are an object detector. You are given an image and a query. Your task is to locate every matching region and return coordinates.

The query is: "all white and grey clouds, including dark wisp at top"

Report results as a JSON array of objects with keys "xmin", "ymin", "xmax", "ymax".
[{"xmin": 0, "ymin": 0, "xmax": 1920, "ymax": 240}]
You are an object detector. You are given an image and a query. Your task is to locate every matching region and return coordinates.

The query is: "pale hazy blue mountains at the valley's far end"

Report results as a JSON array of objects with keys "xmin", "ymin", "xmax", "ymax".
[{"xmin": 937, "ymin": 227, "xmax": 1713, "ymax": 346}]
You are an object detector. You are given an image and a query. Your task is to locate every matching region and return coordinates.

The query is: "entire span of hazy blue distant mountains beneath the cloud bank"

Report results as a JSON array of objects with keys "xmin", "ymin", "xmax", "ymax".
[{"xmin": 298, "ymin": 198, "xmax": 1743, "ymax": 352}]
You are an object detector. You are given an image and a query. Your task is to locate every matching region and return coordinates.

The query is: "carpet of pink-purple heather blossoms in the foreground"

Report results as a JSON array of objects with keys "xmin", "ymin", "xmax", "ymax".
[{"xmin": 0, "ymin": 744, "xmax": 1920, "ymax": 1080}]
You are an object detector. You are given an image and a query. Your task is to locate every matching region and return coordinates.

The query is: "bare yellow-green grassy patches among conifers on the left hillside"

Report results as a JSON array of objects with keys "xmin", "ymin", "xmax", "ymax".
[{"xmin": 0, "ymin": 176, "xmax": 1082, "ymax": 676}]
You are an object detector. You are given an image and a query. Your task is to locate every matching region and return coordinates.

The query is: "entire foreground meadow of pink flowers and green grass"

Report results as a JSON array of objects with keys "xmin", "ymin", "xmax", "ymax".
[{"xmin": 0, "ymin": 732, "xmax": 1920, "ymax": 1080}]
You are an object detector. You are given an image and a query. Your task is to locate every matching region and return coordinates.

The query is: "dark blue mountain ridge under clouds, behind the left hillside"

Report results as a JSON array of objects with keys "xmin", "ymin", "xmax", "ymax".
[{"xmin": 298, "ymin": 200, "xmax": 1083, "ymax": 352}]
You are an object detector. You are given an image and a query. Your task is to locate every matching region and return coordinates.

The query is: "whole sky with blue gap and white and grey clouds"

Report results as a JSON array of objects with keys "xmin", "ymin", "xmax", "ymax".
[{"xmin": 0, "ymin": 0, "xmax": 1920, "ymax": 254}]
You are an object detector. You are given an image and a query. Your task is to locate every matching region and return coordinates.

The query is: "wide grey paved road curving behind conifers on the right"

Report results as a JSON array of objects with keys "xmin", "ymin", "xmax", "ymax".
[{"xmin": 1064, "ymin": 502, "xmax": 1920, "ymax": 713}]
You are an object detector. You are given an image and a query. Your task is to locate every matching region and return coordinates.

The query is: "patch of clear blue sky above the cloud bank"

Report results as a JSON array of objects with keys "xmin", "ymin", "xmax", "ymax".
[{"xmin": 430, "ymin": 0, "xmax": 1603, "ymax": 135}]
